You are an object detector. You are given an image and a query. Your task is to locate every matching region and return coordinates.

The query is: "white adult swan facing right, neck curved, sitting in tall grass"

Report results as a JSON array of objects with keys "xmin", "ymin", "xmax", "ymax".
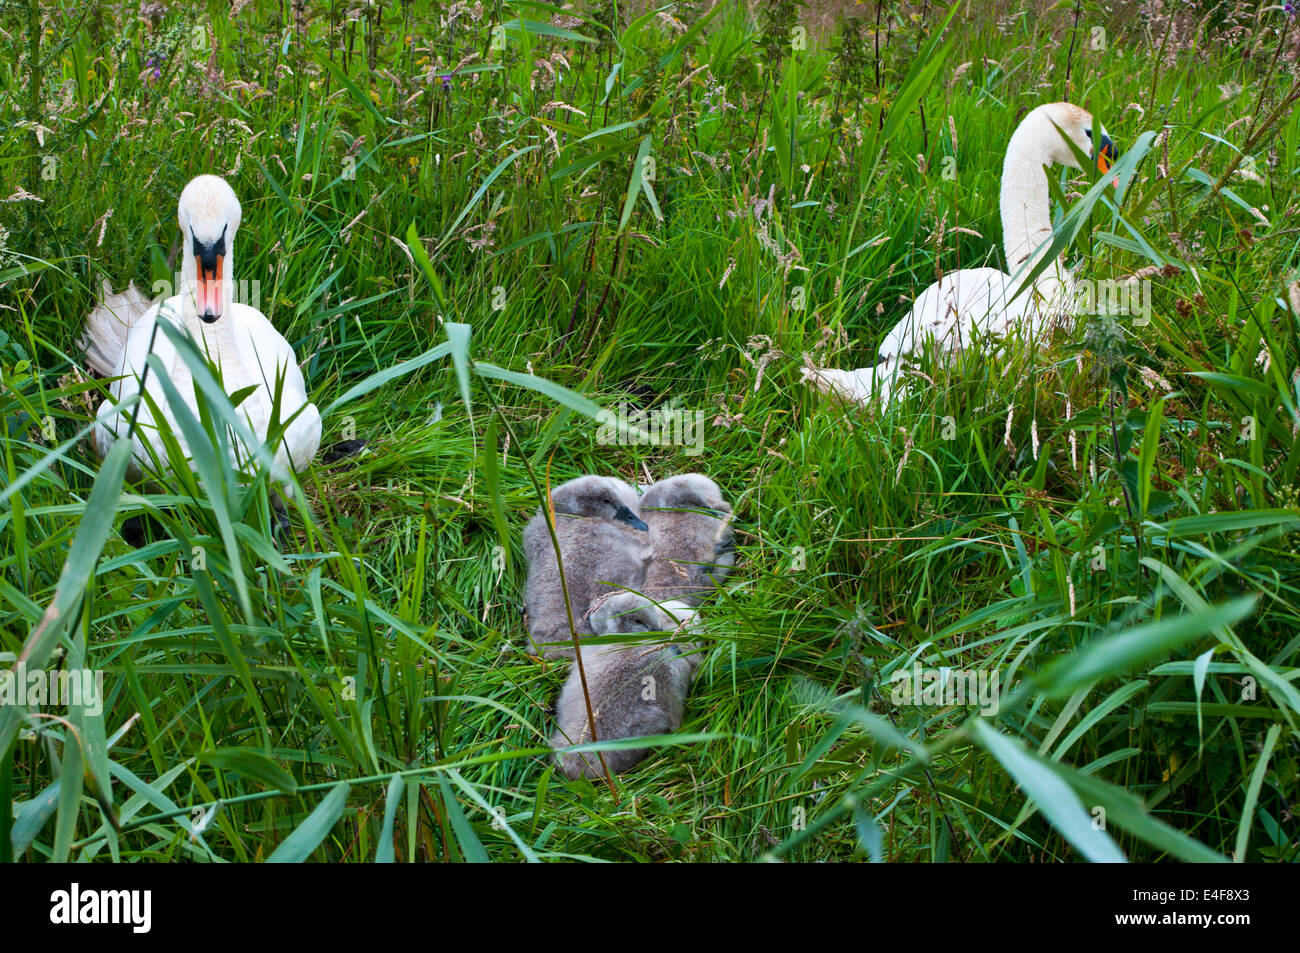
[{"xmin": 803, "ymin": 103, "xmax": 1115, "ymax": 404}]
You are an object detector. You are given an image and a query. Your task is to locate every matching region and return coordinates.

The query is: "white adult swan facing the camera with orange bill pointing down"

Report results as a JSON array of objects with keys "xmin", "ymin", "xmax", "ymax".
[{"xmin": 82, "ymin": 176, "xmax": 321, "ymax": 494}]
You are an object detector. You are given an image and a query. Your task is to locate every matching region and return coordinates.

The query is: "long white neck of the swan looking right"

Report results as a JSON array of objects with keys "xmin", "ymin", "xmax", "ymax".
[{"xmin": 1001, "ymin": 116, "xmax": 1074, "ymax": 300}]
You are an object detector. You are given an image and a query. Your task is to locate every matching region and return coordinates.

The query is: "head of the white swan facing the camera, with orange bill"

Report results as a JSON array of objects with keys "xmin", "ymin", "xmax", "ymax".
[{"xmin": 176, "ymin": 176, "xmax": 242, "ymax": 324}]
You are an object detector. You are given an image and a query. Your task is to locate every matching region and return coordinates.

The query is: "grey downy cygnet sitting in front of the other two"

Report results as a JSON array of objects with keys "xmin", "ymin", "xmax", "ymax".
[{"xmin": 551, "ymin": 593, "xmax": 699, "ymax": 779}]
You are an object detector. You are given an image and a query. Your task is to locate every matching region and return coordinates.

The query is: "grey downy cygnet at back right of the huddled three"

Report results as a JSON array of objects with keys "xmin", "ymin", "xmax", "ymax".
[{"xmin": 641, "ymin": 473, "xmax": 736, "ymax": 606}]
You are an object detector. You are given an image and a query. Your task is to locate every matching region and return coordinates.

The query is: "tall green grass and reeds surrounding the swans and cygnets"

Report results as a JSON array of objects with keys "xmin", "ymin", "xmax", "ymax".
[{"xmin": 0, "ymin": 0, "xmax": 1300, "ymax": 861}]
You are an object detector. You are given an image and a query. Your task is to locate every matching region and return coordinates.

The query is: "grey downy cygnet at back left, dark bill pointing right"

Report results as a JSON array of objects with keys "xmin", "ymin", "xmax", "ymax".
[{"xmin": 524, "ymin": 476, "xmax": 651, "ymax": 659}]
